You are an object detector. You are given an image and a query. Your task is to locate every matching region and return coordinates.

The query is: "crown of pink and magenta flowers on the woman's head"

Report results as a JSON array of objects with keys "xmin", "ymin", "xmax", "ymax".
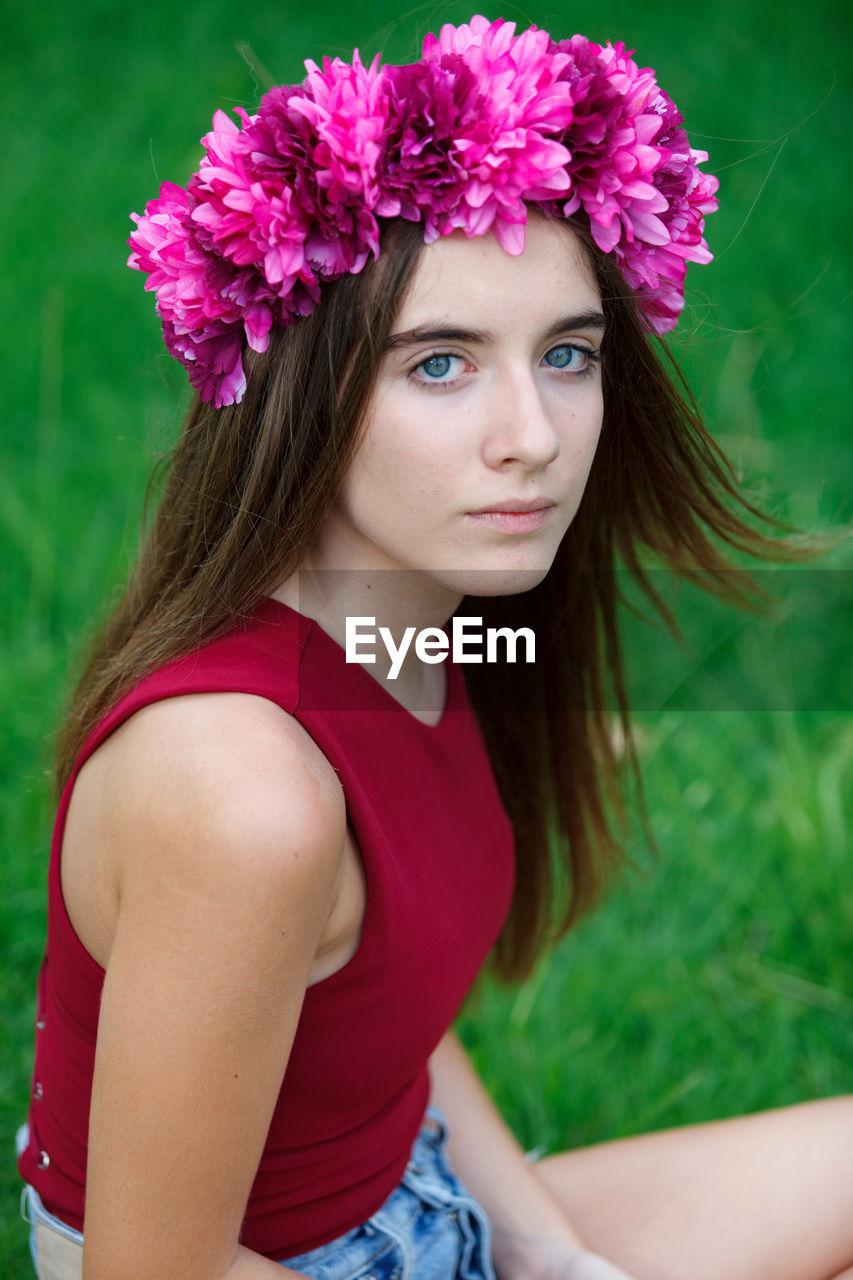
[{"xmin": 128, "ymin": 15, "xmax": 719, "ymax": 408}]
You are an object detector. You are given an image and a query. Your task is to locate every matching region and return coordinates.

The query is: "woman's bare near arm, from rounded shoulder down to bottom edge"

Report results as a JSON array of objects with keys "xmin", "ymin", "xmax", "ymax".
[{"xmin": 78, "ymin": 695, "xmax": 346, "ymax": 1280}]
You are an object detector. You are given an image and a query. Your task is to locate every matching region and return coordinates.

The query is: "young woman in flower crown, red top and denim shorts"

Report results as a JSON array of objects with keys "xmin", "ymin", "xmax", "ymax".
[{"xmin": 14, "ymin": 18, "xmax": 853, "ymax": 1280}]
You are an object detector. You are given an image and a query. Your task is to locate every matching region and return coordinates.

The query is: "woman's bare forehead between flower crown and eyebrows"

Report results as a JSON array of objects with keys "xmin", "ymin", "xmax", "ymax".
[{"xmin": 397, "ymin": 215, "xmax": 601, "ymax": 328}]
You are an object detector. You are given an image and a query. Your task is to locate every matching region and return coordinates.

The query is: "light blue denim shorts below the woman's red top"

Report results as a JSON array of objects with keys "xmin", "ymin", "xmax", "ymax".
[{"xmin": 16, "ymin": 1107, "xmax": 497, "ymax": 1280}]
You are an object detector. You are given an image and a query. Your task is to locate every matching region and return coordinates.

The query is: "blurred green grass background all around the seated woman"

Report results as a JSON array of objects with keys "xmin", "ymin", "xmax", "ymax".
[{"xmin": 0, "ymin": 0, "xmax": 853, "ymax": 1280}]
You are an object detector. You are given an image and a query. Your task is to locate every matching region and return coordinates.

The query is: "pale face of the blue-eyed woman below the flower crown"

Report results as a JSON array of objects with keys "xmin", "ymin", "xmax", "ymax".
[{"xmin": 313, "ymin": 216, "xmax": 605, "ymax": 595}]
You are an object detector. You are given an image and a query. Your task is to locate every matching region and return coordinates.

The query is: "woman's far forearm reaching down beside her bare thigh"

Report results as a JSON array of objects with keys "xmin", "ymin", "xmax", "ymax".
[{"xmin": 430, "ymin": 1032, "xmax": 630, "ymax": 1280}]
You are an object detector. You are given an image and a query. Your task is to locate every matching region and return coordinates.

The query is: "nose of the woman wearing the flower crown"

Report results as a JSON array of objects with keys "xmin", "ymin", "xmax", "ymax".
[{"xmin": 483, "ymin": 367, "xmax": 560, "ymax": 471}]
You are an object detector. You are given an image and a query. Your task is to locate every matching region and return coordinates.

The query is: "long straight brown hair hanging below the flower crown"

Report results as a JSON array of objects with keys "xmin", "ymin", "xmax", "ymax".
[{"xmin": 56, "ymin": 223, "xmax": 803, "ymax": 978}]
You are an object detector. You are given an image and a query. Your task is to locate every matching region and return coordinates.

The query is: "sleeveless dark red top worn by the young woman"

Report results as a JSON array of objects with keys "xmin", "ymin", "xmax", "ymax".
[{"xmin": 19, "ymin": 599, "xmax": 514, "ymax": 1258}]
